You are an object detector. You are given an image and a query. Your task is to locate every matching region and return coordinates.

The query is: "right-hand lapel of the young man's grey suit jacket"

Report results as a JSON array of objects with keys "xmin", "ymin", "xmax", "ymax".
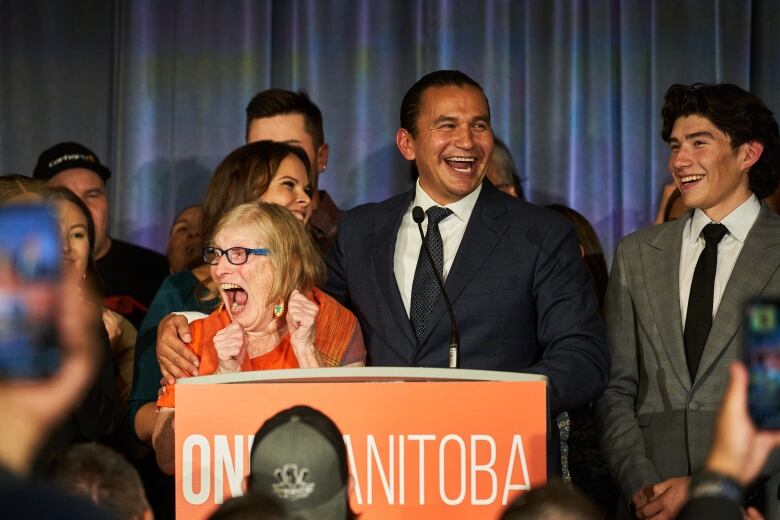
[{"xmin": 696, "ymin": 206, "xmax": 780, "ymax": 382}]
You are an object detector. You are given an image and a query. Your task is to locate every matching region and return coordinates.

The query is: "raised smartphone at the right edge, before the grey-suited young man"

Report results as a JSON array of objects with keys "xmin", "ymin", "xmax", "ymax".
[{"xmin": 744, "ymin": 299, "xmax": 780, "ymax": 430}]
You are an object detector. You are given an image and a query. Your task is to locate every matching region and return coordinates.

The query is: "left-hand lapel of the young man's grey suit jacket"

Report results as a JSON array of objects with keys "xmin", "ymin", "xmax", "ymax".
[{"xmin": 639, "ymin": 213, "xmax": 691, "ymax": 389}]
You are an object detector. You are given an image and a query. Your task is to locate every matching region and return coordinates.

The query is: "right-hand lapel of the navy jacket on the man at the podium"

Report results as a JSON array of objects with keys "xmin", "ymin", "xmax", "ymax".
[{"xmin": 421, "ymin": 181, "xmax": 508, "ymax": 347}]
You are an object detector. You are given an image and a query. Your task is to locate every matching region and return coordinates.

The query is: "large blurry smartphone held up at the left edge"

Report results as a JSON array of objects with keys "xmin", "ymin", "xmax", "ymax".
[{"xmin": 0, "ymin": 204, "xmax": 62, "ymax": 379}]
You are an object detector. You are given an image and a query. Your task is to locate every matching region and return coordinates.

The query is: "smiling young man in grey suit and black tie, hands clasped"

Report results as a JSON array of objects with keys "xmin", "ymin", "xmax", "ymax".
[{"xmin": 596, "ymin": 84, "xmax": 780, "ymax": 520}]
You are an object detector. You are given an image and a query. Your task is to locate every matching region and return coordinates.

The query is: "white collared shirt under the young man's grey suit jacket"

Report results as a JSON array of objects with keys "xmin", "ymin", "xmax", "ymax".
[{"xmin": 680, "ymin": 195, "xmax": 761, "ymax": 328}]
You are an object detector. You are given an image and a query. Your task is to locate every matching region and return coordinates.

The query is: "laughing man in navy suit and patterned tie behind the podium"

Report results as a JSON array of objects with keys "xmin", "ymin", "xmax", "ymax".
[{"xmin": 326, "ymin": 70, "xmax": 609, "ymax": 467}]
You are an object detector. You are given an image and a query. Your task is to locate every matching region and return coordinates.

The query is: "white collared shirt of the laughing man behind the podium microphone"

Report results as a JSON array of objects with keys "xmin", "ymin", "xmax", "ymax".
[{"xmin": 393, "ymin": 179, "xmax": 482, "ymax": 316}]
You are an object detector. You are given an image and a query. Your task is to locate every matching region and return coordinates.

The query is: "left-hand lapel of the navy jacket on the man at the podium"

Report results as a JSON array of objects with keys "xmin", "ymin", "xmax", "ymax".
[{"xmin": 374, "ymin": 191, "xmax": 417, "ymax": 359}]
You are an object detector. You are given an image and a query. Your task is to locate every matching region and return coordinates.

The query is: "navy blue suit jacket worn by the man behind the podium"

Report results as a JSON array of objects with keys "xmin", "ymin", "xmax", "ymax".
[{"xmin": 326, "ymin": 181, "xmax": 609, "ymax": 416}]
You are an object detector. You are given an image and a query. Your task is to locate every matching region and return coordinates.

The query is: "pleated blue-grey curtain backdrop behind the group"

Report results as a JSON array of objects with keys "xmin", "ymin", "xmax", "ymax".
[{"xmin": 0, "ymin": 0, "xmax": 780, "ymax": 256}]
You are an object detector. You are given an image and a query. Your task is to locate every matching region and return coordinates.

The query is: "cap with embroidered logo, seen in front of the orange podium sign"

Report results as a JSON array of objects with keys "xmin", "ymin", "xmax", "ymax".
[{"xmin": 249, "ymin": 406, "xmax": 349, "ymax": 519}]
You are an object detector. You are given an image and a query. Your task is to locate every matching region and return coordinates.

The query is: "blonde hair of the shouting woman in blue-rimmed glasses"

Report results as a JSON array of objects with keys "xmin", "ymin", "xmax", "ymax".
[{"xmin": 209, "ymin": 202, "xmax": 325, "ymax": 303}]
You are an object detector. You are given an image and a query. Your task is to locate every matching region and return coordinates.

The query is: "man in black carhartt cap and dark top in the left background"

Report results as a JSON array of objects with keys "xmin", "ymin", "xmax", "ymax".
[{"xmin": 33, "ymin": 142, "xmax": 168, "ymax": 328}]
